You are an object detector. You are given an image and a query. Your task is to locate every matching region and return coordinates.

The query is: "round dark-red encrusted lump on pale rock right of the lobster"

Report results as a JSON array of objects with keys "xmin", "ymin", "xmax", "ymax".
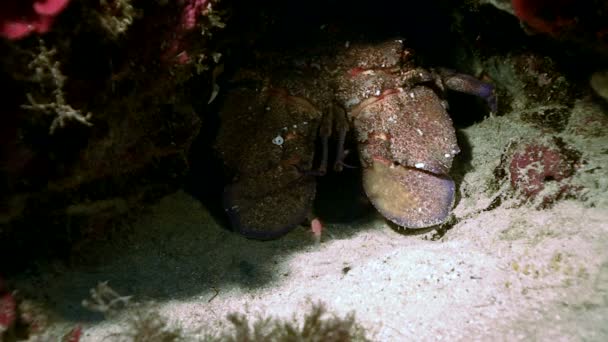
[{"xmin": 506, "ymin": 137, "xmax": 580, "ymax": 207}]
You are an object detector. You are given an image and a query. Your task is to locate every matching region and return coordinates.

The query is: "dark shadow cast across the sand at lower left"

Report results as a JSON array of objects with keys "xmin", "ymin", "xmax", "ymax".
[{"xmin": 12, "ymin": 179, "xmax": 382, "ymax": 322}]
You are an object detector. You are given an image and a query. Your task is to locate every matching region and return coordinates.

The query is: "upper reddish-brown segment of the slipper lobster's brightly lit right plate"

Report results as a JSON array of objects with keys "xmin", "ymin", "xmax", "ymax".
[{"xmin": 352, "ymin": 86, "xmax": 460, "ymax": 174}]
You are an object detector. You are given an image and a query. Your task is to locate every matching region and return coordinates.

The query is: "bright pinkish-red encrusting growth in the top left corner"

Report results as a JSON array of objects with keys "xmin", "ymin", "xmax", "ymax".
[{"xmin": 0, "ymin": 0, "xmax": 69, "ymax": 40}]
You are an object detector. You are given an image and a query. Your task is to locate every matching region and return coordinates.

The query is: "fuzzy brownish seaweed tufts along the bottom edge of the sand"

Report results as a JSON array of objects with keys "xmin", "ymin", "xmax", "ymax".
[{"xmin": 81, "ymin": 282, "xmax": 369, "ymax": 342}]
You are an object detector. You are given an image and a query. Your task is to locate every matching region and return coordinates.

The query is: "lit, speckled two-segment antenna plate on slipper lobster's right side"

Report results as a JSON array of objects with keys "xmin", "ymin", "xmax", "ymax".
[{"xmin": 353, "ymin": 86, "xmax": 459, "ymax": 228}]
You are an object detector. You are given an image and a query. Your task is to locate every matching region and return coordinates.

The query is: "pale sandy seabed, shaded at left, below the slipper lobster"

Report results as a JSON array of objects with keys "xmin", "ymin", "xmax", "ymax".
[{"xmin": 17, "ymin": 97, "xmax": 608, "ymax": 341}]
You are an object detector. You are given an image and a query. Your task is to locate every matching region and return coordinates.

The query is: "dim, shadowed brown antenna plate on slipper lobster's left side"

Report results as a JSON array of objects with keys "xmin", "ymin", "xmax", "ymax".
[{"xmin": 216, "ymin": 71, "xmax": 322, "ymax": 239}]
